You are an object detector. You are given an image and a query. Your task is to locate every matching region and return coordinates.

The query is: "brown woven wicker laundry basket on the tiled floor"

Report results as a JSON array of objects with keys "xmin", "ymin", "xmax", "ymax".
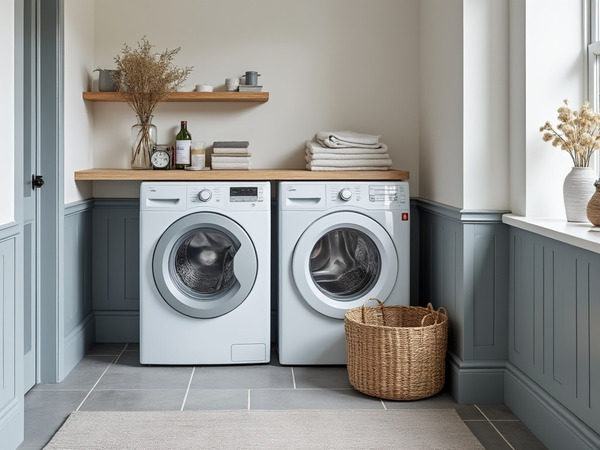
[{"xmin": 344, "ymin": 299, "xmax": 448, "ymax": 400}]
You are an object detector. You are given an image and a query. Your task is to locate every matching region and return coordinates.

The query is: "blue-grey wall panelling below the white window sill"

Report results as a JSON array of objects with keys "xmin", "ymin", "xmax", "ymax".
[{"xmin": 506, "ymin": 228, "xmax": 600, "ymax": 448}]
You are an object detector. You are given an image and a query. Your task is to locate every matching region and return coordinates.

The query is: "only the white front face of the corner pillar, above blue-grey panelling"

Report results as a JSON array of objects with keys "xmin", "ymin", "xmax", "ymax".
[{"xmin": 462, "ymin": 0, "xmax": 510, "ymax": 210}]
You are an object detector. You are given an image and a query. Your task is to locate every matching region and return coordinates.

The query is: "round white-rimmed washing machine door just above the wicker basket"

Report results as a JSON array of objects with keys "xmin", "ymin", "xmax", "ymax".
[{"xmin": 292, "ymin": 211, "xmax": 398, "ymax": 319}]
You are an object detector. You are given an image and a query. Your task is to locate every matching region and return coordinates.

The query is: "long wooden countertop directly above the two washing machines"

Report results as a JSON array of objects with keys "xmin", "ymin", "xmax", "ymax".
[{"xmin": 75, "ymin": 169, "xmax": 409, "ymax": 181}]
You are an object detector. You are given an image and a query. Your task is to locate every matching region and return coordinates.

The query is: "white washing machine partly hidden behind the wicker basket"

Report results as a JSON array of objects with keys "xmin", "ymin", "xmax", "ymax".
[{"xmin": 278, "ymin": 181, "xmax": 410, "ymax": 365}]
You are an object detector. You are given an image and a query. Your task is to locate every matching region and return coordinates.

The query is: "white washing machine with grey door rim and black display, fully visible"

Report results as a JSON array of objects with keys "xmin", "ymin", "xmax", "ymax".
[{"xmin": 140, "ymin": 182, "xmax": 271, "ymax": 365}]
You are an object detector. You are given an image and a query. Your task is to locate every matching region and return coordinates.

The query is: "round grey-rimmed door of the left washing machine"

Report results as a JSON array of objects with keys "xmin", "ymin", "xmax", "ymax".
[{"xmin": 152, "ymin": 212, "xmax": 258, "ymax": 319}]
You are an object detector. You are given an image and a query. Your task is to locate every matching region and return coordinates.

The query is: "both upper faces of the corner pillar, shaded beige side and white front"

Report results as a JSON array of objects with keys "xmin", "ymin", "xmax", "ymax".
[{"xmin": 419, "ymin": 0, "xmax": 509, "ymax": 210}]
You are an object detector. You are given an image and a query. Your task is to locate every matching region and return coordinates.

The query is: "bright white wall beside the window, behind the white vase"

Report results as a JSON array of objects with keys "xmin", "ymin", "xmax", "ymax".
[{"xmin": 511, "ymin": 0, "xmax": 585, "ymax": 217}]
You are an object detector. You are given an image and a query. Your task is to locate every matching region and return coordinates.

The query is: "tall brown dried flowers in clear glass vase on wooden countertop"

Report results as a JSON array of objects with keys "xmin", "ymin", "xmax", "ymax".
[{"xmin": 115, "ymin": 36, "xmax": 192, "ymax": 168}]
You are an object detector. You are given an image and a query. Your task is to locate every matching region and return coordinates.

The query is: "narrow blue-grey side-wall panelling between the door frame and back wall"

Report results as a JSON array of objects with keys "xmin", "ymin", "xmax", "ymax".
[{"xmin": 61, "ymin": 201, "xmax": 95, "ymax": 374}]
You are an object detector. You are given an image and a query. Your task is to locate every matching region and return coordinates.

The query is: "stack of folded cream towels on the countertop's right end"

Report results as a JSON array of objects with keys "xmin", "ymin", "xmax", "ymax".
[{"xmin": 306, "ymin": 131, "xmax": 392, "ymax": 170}]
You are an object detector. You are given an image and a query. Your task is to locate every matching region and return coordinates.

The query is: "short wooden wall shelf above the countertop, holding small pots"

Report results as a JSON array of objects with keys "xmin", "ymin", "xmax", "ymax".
[{"xmin": 83, "ymin": 92, "xmax": 269, "ymax": 103}]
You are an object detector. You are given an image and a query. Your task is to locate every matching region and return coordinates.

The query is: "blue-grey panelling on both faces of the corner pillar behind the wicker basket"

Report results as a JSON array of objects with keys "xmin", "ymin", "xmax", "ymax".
[{"xmin": 411, "ymin": 200, "xmax": 508, "ymax": 403}]
